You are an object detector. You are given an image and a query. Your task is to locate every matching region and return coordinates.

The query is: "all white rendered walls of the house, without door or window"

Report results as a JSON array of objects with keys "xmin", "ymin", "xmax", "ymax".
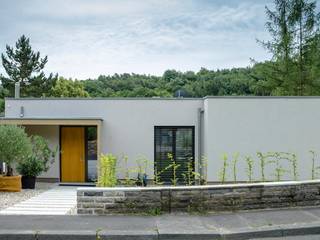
[{"xmin": 5, "ymin": 97, "xmax": 320, "ymax": 181}]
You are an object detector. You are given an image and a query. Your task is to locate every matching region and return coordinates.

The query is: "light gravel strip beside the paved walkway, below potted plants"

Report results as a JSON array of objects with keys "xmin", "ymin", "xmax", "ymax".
[{"xmin": 0, "ymin": 182, "xmax": 57, "ymax": 209}]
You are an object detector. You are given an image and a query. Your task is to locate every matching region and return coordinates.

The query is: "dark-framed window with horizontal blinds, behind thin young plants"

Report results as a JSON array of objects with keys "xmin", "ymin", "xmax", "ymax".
[{"xmin": 154, "ymin": 126, "xmax": 194, "ymax": 184}]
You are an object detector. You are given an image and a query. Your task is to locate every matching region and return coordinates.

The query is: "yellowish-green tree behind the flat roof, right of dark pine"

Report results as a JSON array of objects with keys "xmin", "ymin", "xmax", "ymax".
[{"xmin": 51, "ymin": 77, "xmax": 89, "ymax": 97}]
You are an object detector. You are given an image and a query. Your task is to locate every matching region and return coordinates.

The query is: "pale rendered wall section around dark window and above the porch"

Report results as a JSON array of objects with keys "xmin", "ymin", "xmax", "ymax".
[{"xmin": 5, "ymin": 99, "xmax": 203, "ymax": 178}]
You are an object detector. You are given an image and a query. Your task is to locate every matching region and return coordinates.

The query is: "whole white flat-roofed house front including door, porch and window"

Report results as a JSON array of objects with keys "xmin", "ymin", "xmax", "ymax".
[{"xmin": 0, "ymin": 97, "xmax": 320, "ymax": 183}]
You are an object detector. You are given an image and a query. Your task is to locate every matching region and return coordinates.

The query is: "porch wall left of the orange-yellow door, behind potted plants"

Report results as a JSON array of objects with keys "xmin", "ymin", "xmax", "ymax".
[{"xmin": 25, "ymin": 126, "xmax": 60, "ymax": 179}]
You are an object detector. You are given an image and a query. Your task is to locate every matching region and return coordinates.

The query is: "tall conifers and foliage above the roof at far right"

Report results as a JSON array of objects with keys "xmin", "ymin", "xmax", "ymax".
[{"xmin": 255, "ymin": 0, "xmax": 320, "ymax": 96}]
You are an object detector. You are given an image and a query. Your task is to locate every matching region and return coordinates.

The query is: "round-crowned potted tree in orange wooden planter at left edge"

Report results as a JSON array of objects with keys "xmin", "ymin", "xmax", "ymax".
[{"xmin": 0, "ymin": 125, "xmax": 32, "ymax": 192}]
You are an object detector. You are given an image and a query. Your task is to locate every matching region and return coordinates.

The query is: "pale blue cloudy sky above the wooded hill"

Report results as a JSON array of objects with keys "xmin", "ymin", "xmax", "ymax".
[{"xmin": 0, "ymin": 0, "xmax": 278, "ymax": 79}]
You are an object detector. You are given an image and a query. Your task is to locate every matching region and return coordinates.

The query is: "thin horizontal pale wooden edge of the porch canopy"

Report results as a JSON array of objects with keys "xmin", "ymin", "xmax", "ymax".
[{"xmin": 0, "ymin": 117, "xmax": 103, "ymax": 125}]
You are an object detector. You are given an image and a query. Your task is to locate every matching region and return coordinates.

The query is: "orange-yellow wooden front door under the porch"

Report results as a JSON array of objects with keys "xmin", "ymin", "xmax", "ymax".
[{"xmin": 61, "ymin": 127, "xmax": 85, "ymax": 182}]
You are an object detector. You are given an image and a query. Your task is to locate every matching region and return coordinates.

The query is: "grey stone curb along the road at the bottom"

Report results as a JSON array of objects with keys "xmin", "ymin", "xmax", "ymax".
[{"xmin": 0, "ymin": 224, "xmax": 320, "ymax": 240}]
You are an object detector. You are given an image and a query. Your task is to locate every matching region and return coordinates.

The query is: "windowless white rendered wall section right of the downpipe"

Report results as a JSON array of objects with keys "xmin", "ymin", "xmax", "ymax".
[{"xmin": 204, "ymin": 98, "xmax": 320, "ymax": 181}]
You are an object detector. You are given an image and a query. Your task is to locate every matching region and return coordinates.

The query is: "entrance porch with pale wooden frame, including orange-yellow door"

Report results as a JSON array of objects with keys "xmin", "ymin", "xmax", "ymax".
[{"xmin": 0, "ymin": 118, "xmax": 102, "ymax": 184}]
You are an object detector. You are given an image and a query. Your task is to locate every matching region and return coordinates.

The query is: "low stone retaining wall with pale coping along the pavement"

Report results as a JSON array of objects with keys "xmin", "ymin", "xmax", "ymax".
[{"xmin": 77, "ymin": 180, "xmax": 320, "ymax": 215}]
